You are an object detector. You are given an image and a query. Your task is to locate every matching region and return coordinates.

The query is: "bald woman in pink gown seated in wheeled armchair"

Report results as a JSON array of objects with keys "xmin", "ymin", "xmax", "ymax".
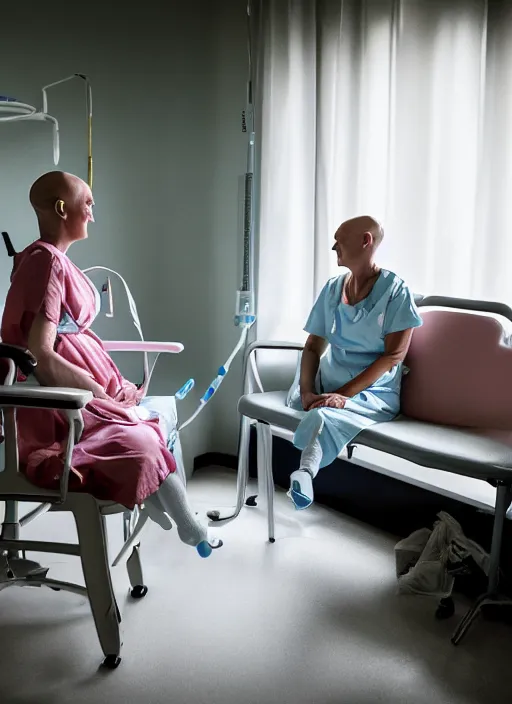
[{"xmin": 1, "ymin": 172, "xmax": 219, "ymax": 557}]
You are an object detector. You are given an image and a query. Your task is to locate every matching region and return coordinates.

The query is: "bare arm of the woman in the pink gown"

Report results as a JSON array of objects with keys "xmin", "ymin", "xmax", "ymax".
[{"xmin": 28, "ymin": 315, "xmax": 109, "ymax": 399}]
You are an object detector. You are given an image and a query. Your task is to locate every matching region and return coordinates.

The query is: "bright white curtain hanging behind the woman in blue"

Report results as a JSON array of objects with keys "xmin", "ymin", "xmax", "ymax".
[{"xmin": 258, "ymin": 0, "xmax": 512, "ymax": 339}]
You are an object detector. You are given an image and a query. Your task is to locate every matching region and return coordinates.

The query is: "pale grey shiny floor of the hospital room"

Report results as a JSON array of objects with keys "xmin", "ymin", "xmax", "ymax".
[{"xmin": 0, "ymin": 468, "xmax": 512, "ymax": 704}]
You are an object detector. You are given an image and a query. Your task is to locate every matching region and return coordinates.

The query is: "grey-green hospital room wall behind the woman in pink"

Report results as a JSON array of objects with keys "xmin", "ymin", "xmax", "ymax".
[{"xmin": 0, "ymin": 0, "xmax": 247, "ymax": 468}]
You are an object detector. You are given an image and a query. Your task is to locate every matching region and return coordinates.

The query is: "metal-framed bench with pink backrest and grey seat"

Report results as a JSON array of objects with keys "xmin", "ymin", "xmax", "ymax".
[{"xmin": 225, "ymin": 296, "xmax": 512, "ymax": 645}]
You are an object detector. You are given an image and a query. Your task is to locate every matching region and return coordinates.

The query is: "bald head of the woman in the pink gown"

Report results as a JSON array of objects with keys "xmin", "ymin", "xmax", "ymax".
[{"xmin": 29, "ymin": 171, "xmax": 93, "ymax": 248}]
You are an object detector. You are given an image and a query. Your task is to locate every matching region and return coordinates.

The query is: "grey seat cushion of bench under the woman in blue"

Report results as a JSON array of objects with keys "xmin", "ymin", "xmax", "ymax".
[{"xmin": 238, "ymin": 391, "xmax": 512, "ymax": 480}]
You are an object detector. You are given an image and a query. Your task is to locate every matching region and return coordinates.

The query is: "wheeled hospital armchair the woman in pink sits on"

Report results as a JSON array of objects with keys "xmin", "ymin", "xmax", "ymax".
[{"xmin": 0, "ymin": 341, "xmax": 183, "ymax": 669}]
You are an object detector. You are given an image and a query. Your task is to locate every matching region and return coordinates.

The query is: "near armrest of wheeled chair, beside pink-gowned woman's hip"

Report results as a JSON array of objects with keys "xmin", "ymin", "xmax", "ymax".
[{"xmin": 0, "ymin": 384, "xmax": 93, "ymax": 411}]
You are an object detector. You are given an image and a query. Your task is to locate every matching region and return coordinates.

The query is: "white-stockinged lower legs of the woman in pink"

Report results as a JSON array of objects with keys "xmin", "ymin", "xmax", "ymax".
[{"xmin": 144, "ymin": 472, "xmax": 222, "ymax": 557}]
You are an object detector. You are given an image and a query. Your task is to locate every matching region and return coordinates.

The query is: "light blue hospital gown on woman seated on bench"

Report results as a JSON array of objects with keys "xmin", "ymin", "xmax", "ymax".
[{"xmin": 287, "ymin": 269, "xmax": 422, "ymax": 467}]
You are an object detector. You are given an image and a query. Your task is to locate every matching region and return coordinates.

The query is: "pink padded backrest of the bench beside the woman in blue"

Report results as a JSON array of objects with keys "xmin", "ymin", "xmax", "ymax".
[{"xmin": 401, "ymin": 299, "xmax": 512, "ymax": 430}]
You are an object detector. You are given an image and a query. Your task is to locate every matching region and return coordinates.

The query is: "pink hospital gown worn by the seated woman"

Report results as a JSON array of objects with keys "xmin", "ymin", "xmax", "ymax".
[{"xmin": 1, "ymin": 240, "xmax": 176, "ymax": 508}]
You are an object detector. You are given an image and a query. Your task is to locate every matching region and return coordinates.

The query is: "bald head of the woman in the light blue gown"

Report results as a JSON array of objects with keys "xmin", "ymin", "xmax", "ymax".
[{"xmin": 333, "ymin": 215, "xmax": 384, "ymax": 268}]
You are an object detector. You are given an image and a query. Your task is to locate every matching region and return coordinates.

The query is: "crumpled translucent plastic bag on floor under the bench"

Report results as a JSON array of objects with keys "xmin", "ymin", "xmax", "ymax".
[{"xmin": 395, "ymin": 511, "xmax": 489, "ymax": 598}]
